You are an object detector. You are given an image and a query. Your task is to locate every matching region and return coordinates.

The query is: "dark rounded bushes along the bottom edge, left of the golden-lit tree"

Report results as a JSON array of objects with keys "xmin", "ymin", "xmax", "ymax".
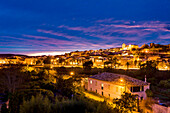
[{"xmin": 20, "ymin": 95, "xmax": 115, "ymax": 113}]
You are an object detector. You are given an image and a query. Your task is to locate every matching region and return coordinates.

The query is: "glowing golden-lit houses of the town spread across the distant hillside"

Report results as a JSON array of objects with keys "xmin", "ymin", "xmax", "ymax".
[{"xmin": 0, "ymin": 43, "xmax": 170, "ymax": 70}]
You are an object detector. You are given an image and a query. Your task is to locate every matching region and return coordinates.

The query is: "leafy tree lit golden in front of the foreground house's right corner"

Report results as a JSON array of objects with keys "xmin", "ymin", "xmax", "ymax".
[{"xmin": 113, "ymin": 93, "xmax": 138, "ymax": 113}]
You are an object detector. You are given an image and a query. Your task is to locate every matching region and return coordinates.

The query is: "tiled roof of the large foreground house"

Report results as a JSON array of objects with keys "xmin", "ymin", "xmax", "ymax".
[{"xmin": 89, "ymin": 72, "xmax": 149, "ymax": 86}]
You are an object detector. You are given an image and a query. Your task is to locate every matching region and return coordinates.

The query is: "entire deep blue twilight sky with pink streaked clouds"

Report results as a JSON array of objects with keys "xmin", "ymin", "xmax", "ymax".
[{"xmin": 0, "ymin": 0, "xmax": 170, "ymax": 54}]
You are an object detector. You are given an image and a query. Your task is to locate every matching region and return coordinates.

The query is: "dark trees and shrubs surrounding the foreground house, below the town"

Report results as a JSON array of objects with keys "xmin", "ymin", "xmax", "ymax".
[{"xmin": 0, "ymin": 62, "xmax": 170, "ymax": 113}]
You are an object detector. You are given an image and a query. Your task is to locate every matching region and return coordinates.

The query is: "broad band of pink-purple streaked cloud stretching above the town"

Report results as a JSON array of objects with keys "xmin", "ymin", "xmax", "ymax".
[{"xmin": 0, "ymin": 19, "xmax": 170, "ymax": 52}]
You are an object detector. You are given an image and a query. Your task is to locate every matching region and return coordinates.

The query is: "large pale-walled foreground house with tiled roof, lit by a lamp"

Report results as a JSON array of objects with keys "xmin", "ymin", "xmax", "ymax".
[{"xmin": 88, "ymin": 72, "xmax": 150, "ymax": 99}]
